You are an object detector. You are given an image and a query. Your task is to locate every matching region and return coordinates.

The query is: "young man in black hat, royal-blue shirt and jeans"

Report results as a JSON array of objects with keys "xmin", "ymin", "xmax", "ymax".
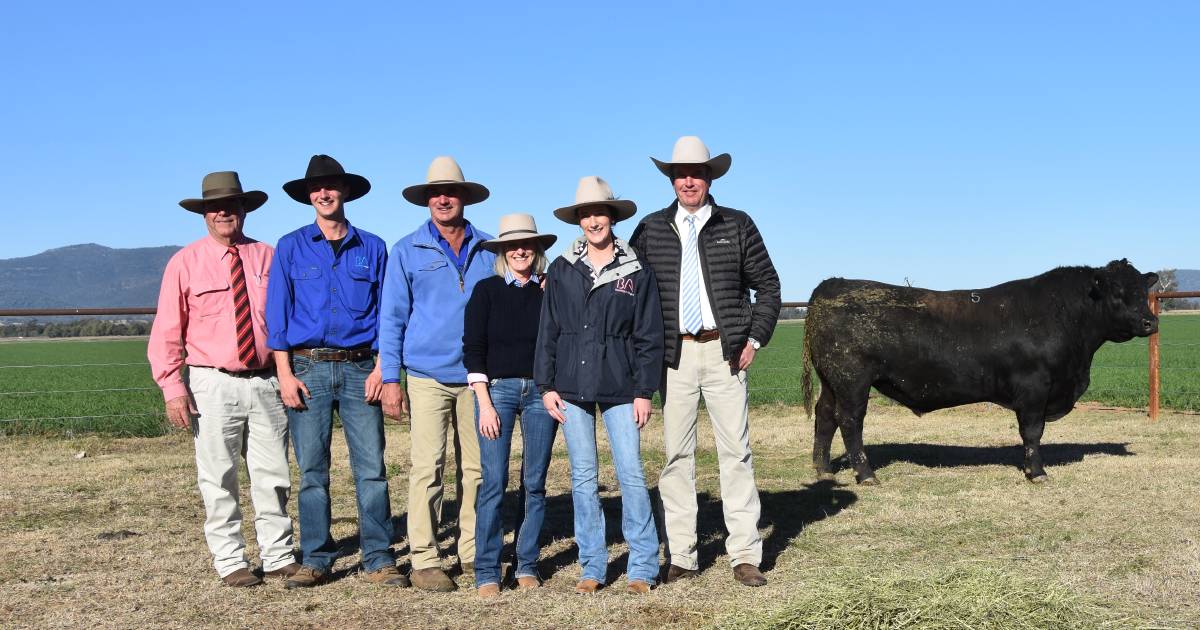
[{"xmin": 266, "ymin": 155, "xmax": 408, "ymax": 588}]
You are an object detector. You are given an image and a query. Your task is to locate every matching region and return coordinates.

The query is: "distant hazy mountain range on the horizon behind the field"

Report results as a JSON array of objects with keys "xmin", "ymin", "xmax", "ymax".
[{"xmin": 0, "ymin": 242, "xmax": 1200, "ymax": 308}]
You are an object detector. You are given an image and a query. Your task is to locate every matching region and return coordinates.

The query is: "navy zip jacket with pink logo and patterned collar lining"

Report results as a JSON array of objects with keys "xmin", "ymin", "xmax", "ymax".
[{"xmin": 533, "ymin": 238, "xmax": 664, "ymax": 404}]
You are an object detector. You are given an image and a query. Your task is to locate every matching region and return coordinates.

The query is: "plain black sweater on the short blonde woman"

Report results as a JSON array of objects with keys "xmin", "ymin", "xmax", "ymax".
[{"xmin": 462, "ymin": 276, "xmax": 541, "ymax": 378}]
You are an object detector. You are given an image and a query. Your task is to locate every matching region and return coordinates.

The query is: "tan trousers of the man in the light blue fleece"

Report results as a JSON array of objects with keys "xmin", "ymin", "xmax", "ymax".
[{"xmin": 408, "ymin": 374, "xmax": 482, "ymax": 569}]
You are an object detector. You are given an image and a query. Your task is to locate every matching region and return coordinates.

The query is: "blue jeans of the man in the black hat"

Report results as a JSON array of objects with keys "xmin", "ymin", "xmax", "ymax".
[{"xmin": 288, "ymin": 356, "xmax": 396, "ymax": 571}]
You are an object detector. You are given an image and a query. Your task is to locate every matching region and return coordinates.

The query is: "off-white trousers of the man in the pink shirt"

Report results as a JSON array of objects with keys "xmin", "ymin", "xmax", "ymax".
[{"xmin": 187, "ymin": 367, "xmax": 295, "ymax": 577}]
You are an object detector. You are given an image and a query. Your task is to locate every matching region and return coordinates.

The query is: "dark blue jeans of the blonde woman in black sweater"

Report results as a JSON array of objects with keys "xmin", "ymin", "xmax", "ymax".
[{"xmin": 475, "ymin": 378, "xmax": 558, "ymax": 588}]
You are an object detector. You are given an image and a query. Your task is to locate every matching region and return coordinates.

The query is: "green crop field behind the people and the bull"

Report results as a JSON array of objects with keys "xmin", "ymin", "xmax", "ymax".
[{"xmin": 0, "ymin": 314, "xmax": 1200, "ymax": 436}]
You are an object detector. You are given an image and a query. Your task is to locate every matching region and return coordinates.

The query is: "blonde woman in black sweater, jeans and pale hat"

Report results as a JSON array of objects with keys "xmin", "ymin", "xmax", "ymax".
[{"xmin": 462, "ymin": 214, "xmax": 558, "ymax": 598}]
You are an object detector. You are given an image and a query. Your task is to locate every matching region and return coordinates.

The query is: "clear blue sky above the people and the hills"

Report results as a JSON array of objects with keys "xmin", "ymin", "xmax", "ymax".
[{"xmin": 0, "ymin": 1, "xmax": 1200, "ymax": 300}]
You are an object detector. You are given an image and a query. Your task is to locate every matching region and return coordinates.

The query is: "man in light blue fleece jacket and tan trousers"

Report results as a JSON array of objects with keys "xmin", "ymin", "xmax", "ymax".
[{"xmin": 379, "ymin": 156, "xmax": 496, "ymax": 592}]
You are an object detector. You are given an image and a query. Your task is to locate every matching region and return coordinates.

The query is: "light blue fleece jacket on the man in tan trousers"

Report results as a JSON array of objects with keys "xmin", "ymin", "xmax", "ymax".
[{"xmin": 379, "ymin": 220, "xmax": 496, "ymax": 383}]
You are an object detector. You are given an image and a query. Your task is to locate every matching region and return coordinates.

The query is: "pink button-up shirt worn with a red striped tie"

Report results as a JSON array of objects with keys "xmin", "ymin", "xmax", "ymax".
[{"xmin": 146, "ymin": 236, "xmax": 275, "ymax": 401}]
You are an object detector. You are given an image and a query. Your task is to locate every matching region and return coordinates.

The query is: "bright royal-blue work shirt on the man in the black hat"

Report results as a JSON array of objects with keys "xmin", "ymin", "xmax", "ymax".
[{"xmin": 266, "ymin": 223, "xmax": 388, "ymax": 350}]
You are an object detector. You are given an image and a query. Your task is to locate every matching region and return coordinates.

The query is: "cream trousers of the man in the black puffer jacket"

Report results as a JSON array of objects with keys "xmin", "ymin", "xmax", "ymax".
[{"xmin": 659, "ymin": 340, "xmax": 762, "ymax": 569}]
